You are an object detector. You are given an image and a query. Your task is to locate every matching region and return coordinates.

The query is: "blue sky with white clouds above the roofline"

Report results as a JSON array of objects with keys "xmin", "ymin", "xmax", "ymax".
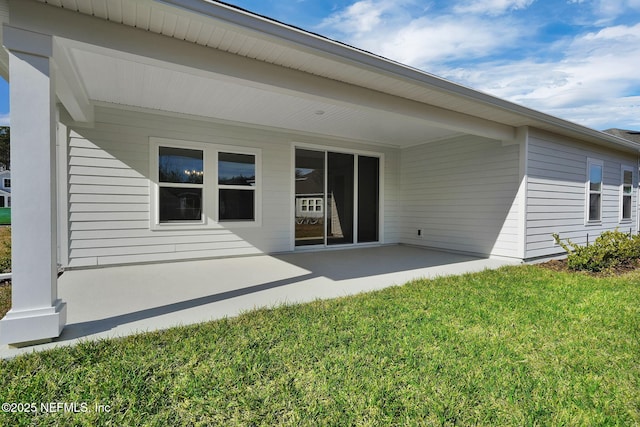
[{"xmin": 0, "ymin": 0, "xmax": 640, "ymax": 130}]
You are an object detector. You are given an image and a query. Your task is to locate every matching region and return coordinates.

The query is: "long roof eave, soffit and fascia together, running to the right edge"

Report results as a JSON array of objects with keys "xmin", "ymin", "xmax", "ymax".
[{"xmin": 32, "ymin": 0, "xmax": 638, "ymax": 150}]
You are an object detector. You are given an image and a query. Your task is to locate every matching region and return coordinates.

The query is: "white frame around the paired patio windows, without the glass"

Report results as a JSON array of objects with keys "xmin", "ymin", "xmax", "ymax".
[{"xmin": 149, "ymin": 137, "xmax": 262, "ymax": 230}]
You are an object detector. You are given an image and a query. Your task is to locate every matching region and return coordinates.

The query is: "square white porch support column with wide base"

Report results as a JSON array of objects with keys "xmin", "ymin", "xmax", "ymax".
[{"xmin": 0, "ymin": 25, "xmax": 67, "ymax": 345}]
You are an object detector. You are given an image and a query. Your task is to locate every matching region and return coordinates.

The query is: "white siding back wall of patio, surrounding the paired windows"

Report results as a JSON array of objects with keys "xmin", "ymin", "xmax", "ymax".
[{"xmin": 62, "ymin": 107, "xmax": 398, "ymax": 267}]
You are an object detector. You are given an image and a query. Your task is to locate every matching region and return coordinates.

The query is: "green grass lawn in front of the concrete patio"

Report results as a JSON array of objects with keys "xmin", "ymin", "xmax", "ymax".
[{"xmin": 0, "ymin": 266, "xmax": 640, "ymax": 426}]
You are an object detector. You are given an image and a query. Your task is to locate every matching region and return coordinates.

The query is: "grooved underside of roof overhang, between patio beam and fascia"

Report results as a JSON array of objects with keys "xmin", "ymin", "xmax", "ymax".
[{"xmin": 37, "ymin": 0, "xmax": 528, "ymax": 126}]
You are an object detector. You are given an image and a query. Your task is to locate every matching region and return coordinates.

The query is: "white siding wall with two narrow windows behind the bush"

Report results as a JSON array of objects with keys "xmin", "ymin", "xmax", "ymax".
[{"xmin": 526, "ymin": 131, "xmax": 638, "ymax": 259}]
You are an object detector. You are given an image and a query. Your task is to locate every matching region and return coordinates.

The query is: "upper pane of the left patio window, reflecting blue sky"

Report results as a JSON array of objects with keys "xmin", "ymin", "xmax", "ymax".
[{"xmin": 158, "ymin": 147, "xmax": 204, "ymax": 184}]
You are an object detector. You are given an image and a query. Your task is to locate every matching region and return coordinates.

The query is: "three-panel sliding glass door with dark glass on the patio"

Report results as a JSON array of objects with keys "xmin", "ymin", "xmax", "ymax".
[{"xmin": 295, "ymin": 148, "xmax": 380, "ymax": 246}]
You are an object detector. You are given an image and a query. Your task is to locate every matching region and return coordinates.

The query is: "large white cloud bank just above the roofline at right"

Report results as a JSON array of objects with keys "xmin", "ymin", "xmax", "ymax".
[{"xmin": 441, "ymin": 24, "xmax": 640, "ymax": 128}]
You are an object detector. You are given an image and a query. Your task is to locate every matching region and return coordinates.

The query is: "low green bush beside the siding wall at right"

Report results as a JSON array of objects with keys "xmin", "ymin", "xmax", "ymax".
[{"xmin": 553, "ymin": 229, "xmax": 640, "ymax": 272}]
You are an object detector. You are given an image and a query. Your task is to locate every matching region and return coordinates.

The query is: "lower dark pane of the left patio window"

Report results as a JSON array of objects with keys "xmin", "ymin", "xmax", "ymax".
[{"xmin": 160, "ymin": 187, "xmax": 202, "ymax": 222}]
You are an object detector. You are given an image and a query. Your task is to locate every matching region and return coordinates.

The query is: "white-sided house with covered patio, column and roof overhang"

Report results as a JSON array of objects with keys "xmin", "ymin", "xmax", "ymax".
[{"xmin": 0, "ymin": 0, "xmax": 640, "ymax": 344}]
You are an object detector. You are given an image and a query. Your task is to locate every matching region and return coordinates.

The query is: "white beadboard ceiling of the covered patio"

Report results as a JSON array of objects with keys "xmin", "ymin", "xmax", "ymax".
[{"xmin": 70, "ymin": 48, "xmax": 458, "ymax": 146}]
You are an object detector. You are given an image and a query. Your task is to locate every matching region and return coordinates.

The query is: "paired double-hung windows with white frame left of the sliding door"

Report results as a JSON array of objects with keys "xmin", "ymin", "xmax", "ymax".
[{"xmin": 150, "ymin": 138, "xmax": 260, "ymax": 229}]
